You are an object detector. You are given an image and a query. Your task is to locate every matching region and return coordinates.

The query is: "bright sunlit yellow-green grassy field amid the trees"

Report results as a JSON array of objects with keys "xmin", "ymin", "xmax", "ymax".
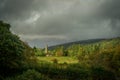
[{"xmin": 38, "ymin": 56, "xmax": 78, "ymax": 64}]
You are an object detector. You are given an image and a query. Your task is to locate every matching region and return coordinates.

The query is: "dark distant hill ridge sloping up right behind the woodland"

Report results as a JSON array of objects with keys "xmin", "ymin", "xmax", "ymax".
[{"xmin": 48, "ymin": 37, "xmax": 120, "ymax": 50}]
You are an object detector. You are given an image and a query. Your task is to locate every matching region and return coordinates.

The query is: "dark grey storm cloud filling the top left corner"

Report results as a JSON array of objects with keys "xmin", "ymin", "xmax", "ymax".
[{"xmin": 0, "ymin": 0, "xmax": 46, "ymax": 20}]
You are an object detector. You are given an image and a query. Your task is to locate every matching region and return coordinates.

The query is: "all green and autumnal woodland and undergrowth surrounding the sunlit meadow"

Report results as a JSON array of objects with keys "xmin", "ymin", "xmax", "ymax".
[{"xmin": 0, "ymin": 21, "xmax": 120, "ymax": 80}]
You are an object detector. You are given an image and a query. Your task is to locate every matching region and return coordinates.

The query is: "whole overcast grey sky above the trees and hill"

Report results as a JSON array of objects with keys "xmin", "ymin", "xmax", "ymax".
[{"xmin": 0, "ymin": 0, "xmax": 120, "ymax": 47}]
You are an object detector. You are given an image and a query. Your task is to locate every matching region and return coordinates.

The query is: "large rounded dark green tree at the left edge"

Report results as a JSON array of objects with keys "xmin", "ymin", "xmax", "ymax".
[{"xmin": 0, "ymin": 21, "xmax": 25, "ymax": 75}]
